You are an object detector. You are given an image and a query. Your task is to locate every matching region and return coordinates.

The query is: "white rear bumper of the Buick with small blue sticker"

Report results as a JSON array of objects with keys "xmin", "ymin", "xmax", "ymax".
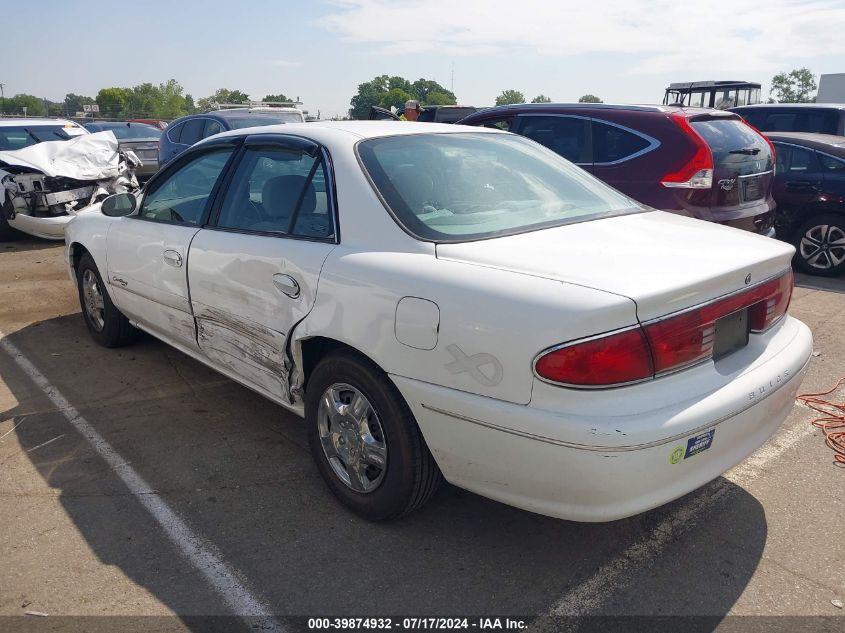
[{"xmin": 392, "ymin": 318, "xmax": 812, "ymax": 521}]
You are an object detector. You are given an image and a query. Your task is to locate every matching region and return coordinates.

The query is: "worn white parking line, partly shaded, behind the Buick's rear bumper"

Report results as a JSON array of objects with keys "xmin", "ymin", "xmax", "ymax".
[{"xmin": 546, "ymin": 404, "xmax": 815, "ymax": 616}]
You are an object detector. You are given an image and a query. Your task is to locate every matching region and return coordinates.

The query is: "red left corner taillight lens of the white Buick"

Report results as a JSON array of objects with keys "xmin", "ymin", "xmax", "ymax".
[{"xmin": 535, "ymin": 328, "xmax": 654, "ymax": 387}]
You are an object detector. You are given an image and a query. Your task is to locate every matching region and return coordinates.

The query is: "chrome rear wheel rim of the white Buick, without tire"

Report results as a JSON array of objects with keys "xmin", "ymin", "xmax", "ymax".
[{"xmin": 317, "ymin": 383, "xmax": 387, "ymax": 493}]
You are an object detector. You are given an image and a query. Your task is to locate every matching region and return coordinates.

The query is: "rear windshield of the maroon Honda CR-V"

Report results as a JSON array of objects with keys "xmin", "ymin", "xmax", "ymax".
[{"xmin": 691, "ymin": 119, "xmax": 773, "ymax": 173}]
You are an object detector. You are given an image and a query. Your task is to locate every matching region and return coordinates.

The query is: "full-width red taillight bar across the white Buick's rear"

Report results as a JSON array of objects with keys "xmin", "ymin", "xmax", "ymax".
[{"xmin": 534, "ymin": 270, "xmax": 794, "ymax": 387}]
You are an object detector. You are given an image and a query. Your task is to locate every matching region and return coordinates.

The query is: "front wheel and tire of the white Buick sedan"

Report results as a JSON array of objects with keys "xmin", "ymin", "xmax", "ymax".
[{"xmin": 76, "ymin": 253, "xmax": 138, "ymax": 347}]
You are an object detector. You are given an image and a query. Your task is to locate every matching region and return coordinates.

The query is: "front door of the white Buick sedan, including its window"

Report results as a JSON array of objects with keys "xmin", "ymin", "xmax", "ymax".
[{"xmin": 106, "ymin": 146, "xmax": 234, "ymax": 349}]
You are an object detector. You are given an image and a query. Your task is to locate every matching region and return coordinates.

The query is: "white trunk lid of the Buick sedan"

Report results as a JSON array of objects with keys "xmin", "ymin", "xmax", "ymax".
[{"xmin": 436, "ymin": 211, "xmax": 795, "ymax": 321}]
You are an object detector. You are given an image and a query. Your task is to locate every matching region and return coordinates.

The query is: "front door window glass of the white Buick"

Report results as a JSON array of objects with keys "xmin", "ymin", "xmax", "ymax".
[{"xmin": 140, "ymin": 147, "xmax": 233, "ymax": 224}]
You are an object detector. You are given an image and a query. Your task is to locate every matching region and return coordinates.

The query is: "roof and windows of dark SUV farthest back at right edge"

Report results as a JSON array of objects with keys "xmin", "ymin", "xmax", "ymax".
[{"xmin": 729, "ymin": 103, "xmax": 845, "ymax": 136}]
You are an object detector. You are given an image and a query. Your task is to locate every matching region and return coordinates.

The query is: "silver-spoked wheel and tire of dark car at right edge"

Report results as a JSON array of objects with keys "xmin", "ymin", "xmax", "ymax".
[{"xmin": 793, "ymin": 213, "xmax": 845, "ymax": 277}]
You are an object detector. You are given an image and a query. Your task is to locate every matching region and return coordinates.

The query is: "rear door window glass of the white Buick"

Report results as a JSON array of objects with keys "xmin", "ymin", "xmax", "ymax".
[{"xmin": 217, "ymin": 147, "xmax": 334, "ymax": 239}]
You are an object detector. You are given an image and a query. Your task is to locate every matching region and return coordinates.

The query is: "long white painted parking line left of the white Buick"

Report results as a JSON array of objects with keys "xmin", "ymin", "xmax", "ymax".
[{"xmin": 0, "ymin": 332, "xmax": 284, "ymax": 633}]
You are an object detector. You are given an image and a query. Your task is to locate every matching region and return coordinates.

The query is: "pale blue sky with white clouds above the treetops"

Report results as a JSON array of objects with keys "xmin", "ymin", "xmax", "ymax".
[{"xmin": 0, "ymin": 0, "xmax": 845, "ymax": 118}]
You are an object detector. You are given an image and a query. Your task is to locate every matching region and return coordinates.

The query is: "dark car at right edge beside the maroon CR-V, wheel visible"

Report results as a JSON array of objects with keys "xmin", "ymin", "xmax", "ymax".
[{"xmin": 767, "ymin": 132, "xmax": 845, "ymax": 277}]
